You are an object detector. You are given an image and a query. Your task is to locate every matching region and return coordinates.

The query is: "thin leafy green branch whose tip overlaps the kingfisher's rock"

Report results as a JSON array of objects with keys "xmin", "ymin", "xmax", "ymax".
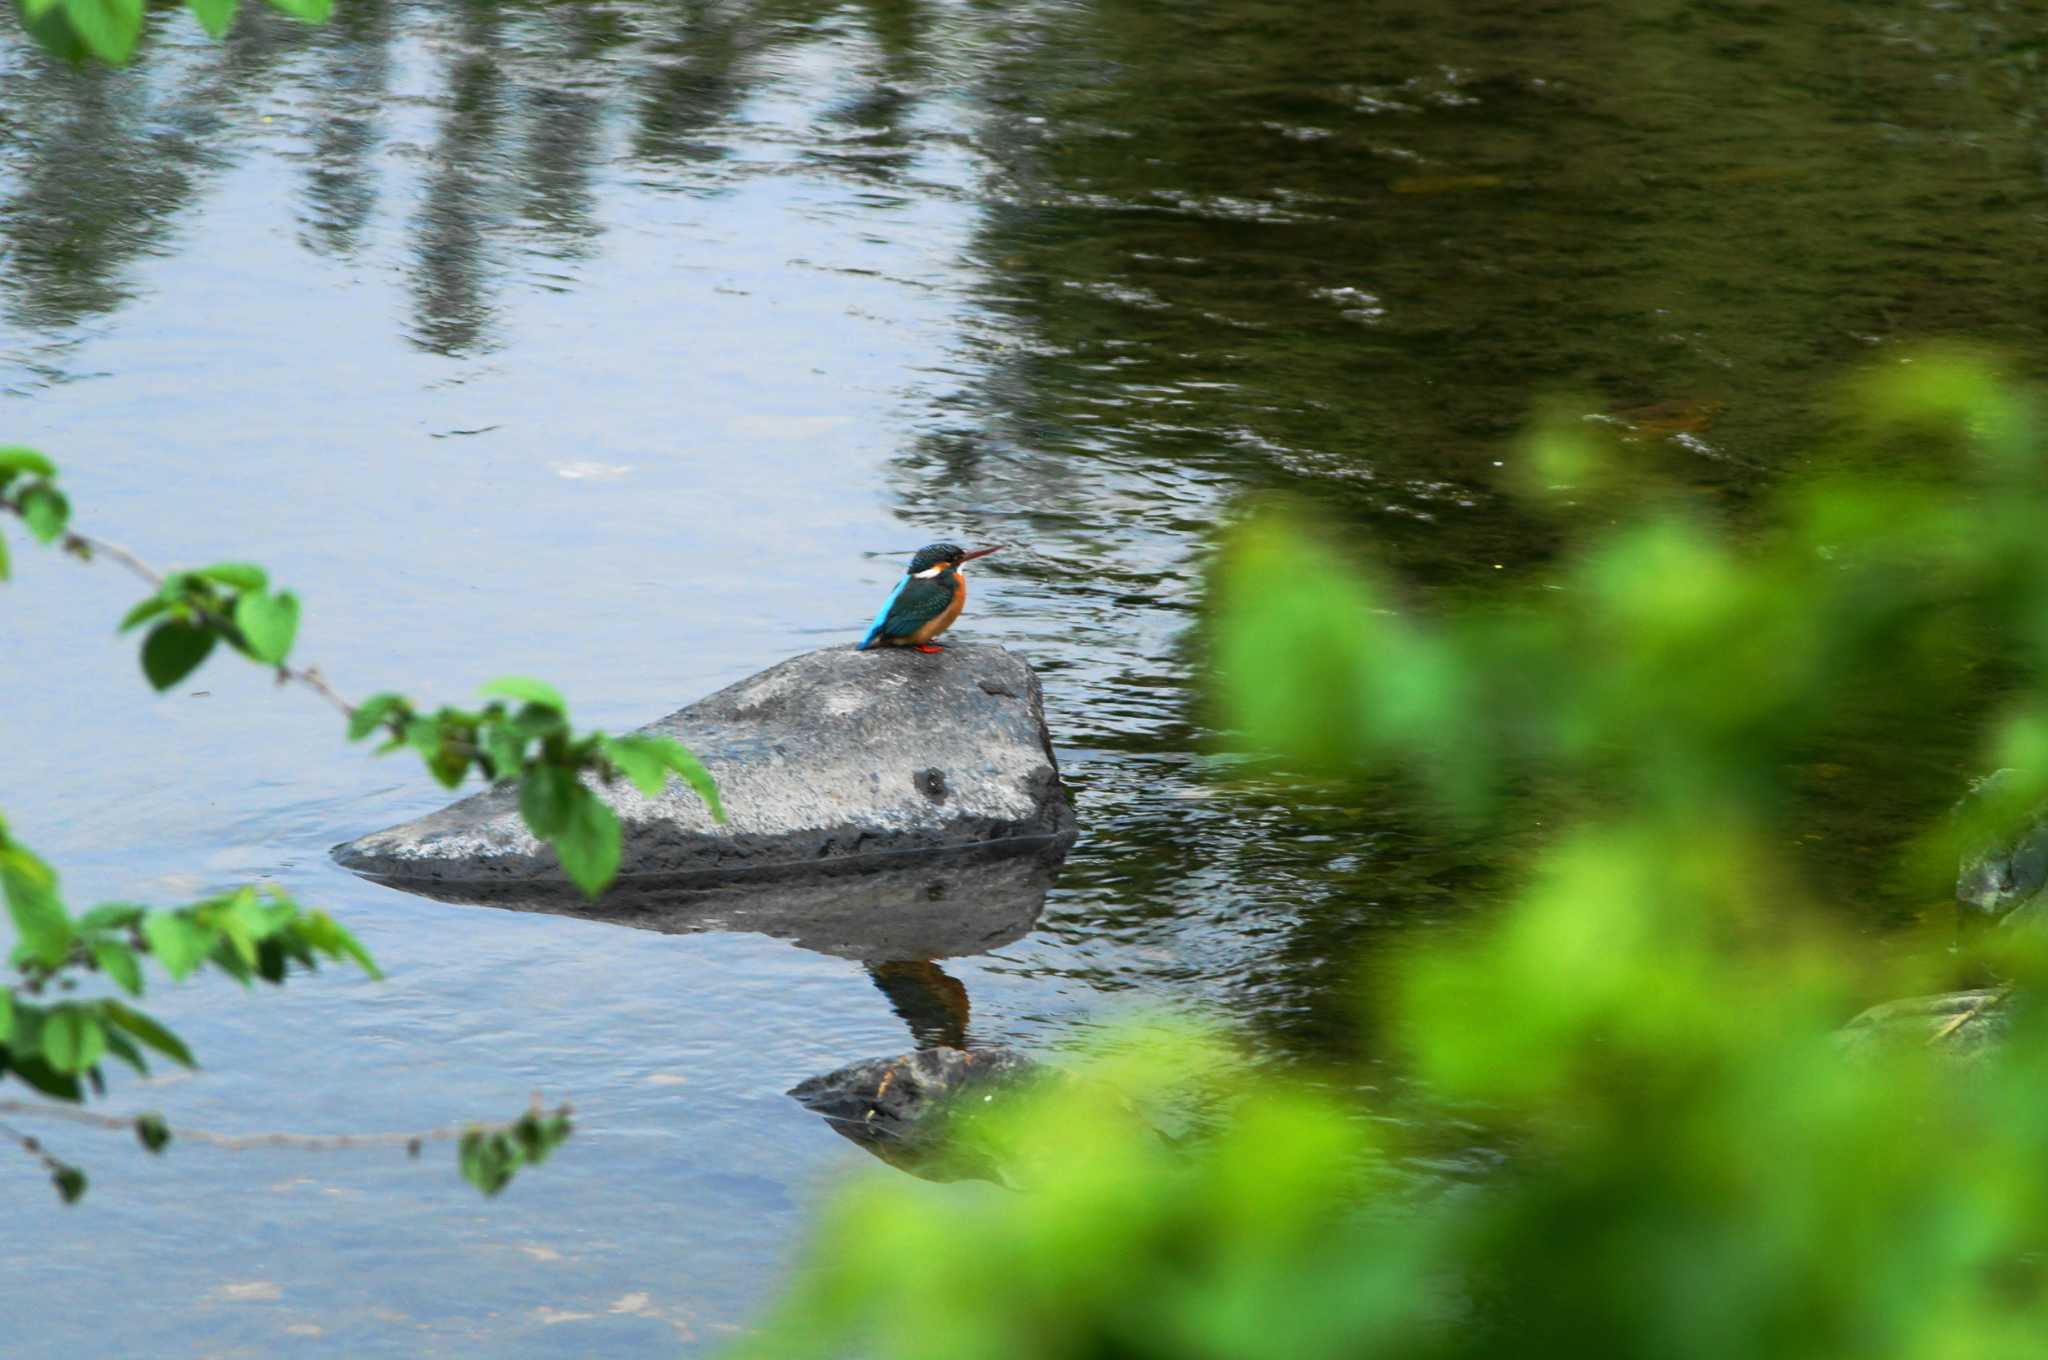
[{"xmin": 0, "ymin": 449, "xmax": 725, "ymax": 897}]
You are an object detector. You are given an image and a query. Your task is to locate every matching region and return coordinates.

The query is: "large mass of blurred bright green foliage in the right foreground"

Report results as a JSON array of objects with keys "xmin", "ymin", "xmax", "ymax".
[{"xmin": 743, "ymin": 352, "xmax": 2048, "ymax": 1360}]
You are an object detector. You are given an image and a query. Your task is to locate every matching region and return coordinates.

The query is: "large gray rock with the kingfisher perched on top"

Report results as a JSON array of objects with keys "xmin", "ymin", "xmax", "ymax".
[{"xmin": 334, "ymin": 643, "xmax": 1073, "ymax": 888}]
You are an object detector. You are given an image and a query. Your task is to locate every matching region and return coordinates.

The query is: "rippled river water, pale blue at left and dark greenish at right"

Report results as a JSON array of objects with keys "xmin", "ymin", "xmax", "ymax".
[{"xmin": 0, "ymin": 0, "xmax": 2048, "ymax": 1356}]
